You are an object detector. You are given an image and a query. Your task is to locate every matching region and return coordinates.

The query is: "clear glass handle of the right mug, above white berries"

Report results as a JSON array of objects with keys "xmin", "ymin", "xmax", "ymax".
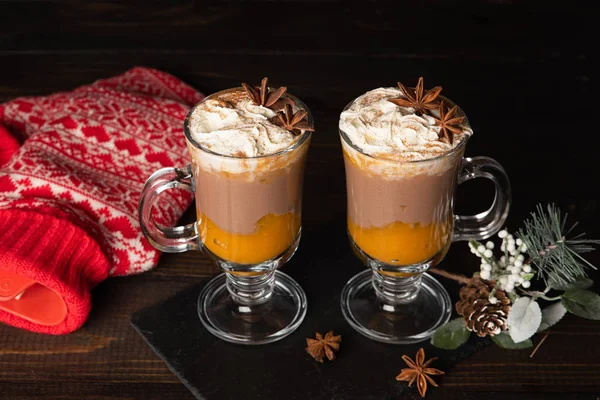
[{"xmin": 452, "ymin": 157, "xmax": 511, "ymax": 241}]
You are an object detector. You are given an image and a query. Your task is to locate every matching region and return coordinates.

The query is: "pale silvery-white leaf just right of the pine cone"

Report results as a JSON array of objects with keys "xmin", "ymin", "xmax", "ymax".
[{"xmin": 506, "ymin": 297, "xmax": 542, "ymax": 343}]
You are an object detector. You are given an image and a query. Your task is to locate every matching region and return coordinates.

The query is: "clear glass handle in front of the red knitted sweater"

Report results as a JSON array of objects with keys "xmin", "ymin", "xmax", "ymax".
[{"xmin": 138, "ymin": 165, "xmax": 200, "ymax": 253}]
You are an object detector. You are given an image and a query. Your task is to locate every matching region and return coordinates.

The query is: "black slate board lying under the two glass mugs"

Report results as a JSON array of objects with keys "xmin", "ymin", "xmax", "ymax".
[{"xmin": 131, "ymin": 228, "xmax": 489, "ymax": 400}]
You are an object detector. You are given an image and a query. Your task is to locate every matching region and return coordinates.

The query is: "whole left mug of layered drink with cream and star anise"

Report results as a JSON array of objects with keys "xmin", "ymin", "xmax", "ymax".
[{"xmin": 139, "ymin": 78, "xmax": 314, "ymax": 344}]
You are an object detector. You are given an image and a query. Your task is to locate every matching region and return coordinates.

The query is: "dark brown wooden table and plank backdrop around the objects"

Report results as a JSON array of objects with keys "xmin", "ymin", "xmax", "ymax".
[{"xmin": 0, "ymin": 0, "xmax": 600, "ymax": 399}]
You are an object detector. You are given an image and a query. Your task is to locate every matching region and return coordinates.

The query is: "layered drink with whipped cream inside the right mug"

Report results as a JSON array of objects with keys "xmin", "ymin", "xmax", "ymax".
[{"xmin": 339, "ymin": 88, "xmax": 472, "ymax": 266}]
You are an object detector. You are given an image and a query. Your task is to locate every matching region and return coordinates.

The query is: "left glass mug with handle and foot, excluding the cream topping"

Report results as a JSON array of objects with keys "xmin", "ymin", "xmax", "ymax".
[{"xmin": 139, "ymin": 89, "xmax": 313, "ymax": 344}]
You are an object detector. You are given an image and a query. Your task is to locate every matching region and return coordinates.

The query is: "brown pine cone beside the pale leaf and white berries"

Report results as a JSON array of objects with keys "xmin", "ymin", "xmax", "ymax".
[{"xmin": 456, "ymin": 277, "xmax": 510, "ymax": 337}]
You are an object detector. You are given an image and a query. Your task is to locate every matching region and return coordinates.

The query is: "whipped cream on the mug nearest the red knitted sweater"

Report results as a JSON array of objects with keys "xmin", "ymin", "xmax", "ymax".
[{"xmin": 189, "ymin": 89, "xmax": 302, "ymax": 157}]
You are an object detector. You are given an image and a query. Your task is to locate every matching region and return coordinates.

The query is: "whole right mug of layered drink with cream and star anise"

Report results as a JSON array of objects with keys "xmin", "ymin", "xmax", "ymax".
[{"xmin": 339, "ymin": 78, "xmax": 510, "ymax": 344}]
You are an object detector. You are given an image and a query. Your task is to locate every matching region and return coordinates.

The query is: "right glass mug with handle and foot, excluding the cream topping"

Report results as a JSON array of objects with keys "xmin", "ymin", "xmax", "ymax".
[{"xmin": 339, "ymin": 96, "xmax": 511, "ymax": 344}]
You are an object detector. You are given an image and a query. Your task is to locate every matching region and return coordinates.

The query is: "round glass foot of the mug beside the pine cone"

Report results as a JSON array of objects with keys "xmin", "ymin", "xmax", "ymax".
[{"xmin": 341, "ymin": 269, "xmax": 452, "ymax": 344}]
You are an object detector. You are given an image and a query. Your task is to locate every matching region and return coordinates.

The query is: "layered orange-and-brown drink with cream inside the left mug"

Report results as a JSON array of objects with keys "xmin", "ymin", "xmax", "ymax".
[{"xmin": 187, "ymin": 88, "xmax": 310, "ymax": 265}]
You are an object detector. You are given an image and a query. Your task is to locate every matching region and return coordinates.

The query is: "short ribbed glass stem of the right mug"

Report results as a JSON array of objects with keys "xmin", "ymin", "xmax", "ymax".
[{"xmin": 373, "ymin": 270, "xmax": 422, "ymax": 311}]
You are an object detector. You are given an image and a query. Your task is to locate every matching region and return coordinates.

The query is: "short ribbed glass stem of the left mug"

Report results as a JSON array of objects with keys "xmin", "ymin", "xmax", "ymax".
[{"xmin": 226, "ymin": 270, "xmax": 275, "ymax": 307}]
